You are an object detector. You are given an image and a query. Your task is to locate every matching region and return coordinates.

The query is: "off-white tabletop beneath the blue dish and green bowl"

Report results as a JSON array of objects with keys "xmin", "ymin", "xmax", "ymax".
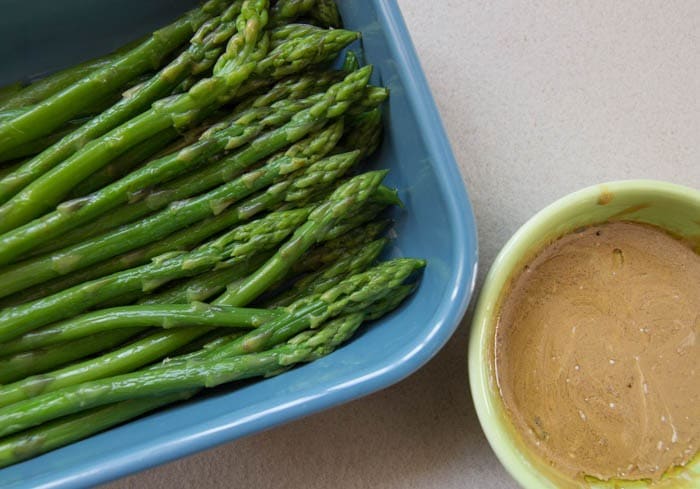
[{"xmin": 104, "ymin": 0, "xmax": 700, "ymax": 489}]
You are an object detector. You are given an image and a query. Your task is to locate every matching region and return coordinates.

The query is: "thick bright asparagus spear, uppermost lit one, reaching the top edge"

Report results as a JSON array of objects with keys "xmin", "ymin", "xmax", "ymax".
[{"xmin": 0, "ymin": 0, "xmax": 225, "ymax": 153}]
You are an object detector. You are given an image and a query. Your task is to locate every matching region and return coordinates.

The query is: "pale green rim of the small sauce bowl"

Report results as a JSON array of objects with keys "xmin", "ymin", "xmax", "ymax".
[{"xmin": 468, "ymin": 179, "xmax": 700, "ymax": 488}]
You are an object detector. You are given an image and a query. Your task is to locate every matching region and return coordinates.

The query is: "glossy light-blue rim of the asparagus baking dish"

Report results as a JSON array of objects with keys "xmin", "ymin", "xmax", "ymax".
[{"xmin": 5, "ymin": 0, "xmax": 478, "ymax": 488}]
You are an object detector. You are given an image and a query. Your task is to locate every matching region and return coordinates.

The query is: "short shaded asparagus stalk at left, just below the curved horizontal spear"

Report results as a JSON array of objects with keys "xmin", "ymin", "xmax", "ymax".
[{"xmin": 0, "ymin": 330, "xmax": 138, "ymax": 384}]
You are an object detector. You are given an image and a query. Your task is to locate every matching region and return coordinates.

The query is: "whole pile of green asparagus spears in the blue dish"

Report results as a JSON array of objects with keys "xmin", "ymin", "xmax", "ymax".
[{"xmin": 0, "ymin": 0, "xmax": 425, "ymax": 467}]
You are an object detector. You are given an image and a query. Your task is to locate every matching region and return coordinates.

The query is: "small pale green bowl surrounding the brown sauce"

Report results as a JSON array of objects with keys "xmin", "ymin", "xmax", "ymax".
[{"xmin": 469, "ymin": 180, "xmax": 700, "ymax": 489}]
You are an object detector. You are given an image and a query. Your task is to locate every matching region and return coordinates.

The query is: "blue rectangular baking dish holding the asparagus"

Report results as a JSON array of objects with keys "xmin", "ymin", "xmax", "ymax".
[{"xmin": 0, "ymin": 0, "xmax": 477, "ymax": 489}]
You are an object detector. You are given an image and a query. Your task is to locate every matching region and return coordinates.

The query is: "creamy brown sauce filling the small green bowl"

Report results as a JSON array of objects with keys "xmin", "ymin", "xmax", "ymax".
[{"xmin": 495, "ymin": 222, "xmax": 700, "ymax": 480}]
